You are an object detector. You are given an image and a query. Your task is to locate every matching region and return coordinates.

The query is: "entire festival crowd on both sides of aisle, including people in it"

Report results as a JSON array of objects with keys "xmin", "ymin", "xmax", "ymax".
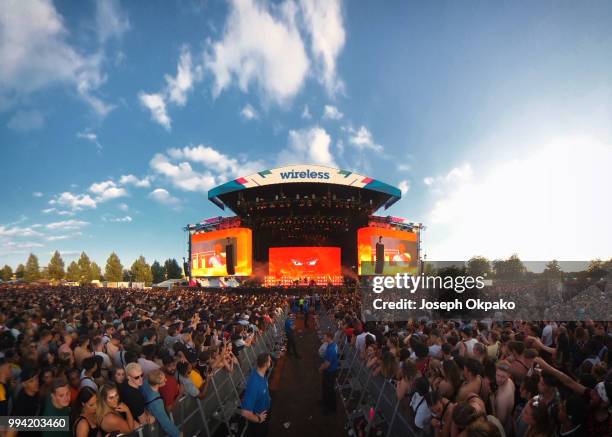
[{"xmin": 0, "ymin": 286, "xmax": 612, "ymax": 437}]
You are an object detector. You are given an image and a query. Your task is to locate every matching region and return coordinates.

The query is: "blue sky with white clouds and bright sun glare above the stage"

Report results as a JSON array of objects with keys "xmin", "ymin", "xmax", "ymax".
[{"xmin": 0, "ymin": 0, "xmax": 612, "ymax": 268}]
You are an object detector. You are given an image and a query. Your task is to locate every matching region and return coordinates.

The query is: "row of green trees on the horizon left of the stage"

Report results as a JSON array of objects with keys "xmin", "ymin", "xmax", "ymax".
[{"xmin": 0, "ymin": 251, "xmax": 183, "ymax": 285}]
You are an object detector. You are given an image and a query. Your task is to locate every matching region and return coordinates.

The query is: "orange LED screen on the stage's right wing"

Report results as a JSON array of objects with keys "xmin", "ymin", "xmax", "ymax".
[{"xmin": 357, "ymin": 227, "xmax": 418, "ymax": 275}]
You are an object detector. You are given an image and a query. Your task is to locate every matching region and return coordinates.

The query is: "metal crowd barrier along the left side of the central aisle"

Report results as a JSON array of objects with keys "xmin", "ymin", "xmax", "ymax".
[{"xmin": 118, "ymin": 307, "xmax": 289, "ymax": 437}]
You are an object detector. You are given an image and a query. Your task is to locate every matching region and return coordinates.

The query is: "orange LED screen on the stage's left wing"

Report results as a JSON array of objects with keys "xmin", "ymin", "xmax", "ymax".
[{"xmin": 191, "ymin": 228, "xmax": 253, "ymax": 276}]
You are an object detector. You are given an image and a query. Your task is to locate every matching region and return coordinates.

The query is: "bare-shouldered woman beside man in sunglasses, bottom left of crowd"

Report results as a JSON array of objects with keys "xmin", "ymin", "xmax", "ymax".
[{"xmin": 96, "ymin": 383, "xmax": 138, "ymax": 434}]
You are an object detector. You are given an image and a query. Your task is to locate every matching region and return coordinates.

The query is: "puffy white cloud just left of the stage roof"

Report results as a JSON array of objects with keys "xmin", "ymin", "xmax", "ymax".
[{"xmin": 150, "ymin": 144, "xmax": 264, "ymax": 192}]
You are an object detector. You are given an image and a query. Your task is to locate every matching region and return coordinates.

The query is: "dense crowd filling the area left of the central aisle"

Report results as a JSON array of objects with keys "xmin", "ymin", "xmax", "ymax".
[{"xmin": 0, "ymin": 286, "xmax": 286, "ymax": 437}]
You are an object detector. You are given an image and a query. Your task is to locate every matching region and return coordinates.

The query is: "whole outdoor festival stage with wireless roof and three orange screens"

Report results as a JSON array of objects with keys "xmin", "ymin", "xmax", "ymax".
[{"xmin": 185, "ymin": 165, "xmax": 422, "ymax": 286}]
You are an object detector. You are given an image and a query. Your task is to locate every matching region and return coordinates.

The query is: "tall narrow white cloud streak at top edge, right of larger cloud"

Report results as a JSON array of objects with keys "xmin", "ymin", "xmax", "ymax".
[{"xmin": 300, "ymin": 0, "xmax": 346, "ymax": 95}]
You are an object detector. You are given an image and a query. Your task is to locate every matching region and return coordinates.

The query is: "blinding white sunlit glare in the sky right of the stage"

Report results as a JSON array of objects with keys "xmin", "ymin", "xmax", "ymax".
[{"xmin": 425, "ymin": 137, "xmax": 612, "ymax": 260}]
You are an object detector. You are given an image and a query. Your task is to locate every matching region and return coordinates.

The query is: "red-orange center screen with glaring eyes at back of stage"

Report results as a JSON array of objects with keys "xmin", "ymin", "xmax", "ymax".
[{"xmin": 269, "ymin": 247, "xmax": 342, "ymax": 278}]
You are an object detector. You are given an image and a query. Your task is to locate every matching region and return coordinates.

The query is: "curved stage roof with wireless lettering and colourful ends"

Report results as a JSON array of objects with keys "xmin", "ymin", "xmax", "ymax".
[{"xmin": 208, "ymin": 164, "xmax": 402, "ymax": 210}]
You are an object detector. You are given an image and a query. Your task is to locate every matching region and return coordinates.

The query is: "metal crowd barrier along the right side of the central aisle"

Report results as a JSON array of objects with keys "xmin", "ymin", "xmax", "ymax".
[{"xmin": 319, "ymin": 311, "xmax": 419, "ymax": 437}]
